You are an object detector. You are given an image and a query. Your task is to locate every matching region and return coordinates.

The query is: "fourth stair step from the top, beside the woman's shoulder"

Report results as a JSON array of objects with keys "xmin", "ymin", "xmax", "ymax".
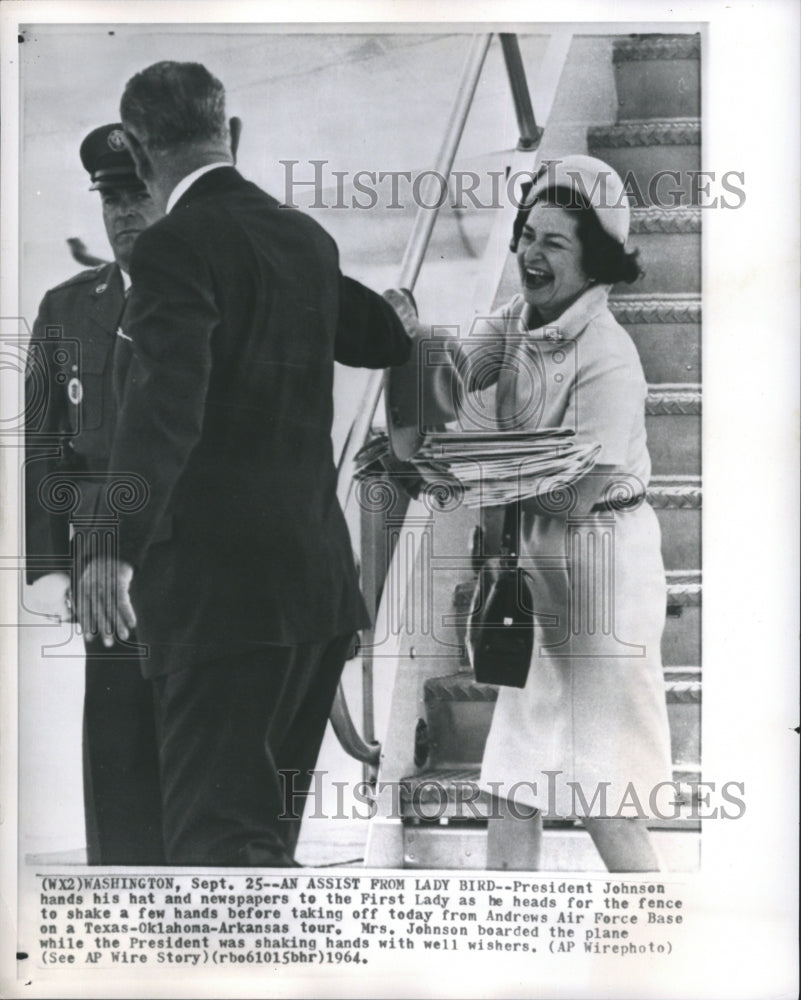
[{"xmin": 609, "ymin": 286, "xmax": 701, "ymax": 384}]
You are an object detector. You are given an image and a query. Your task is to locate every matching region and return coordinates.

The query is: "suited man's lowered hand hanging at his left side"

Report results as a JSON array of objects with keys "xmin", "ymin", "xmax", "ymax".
[{"xmin": 77, "ymin": 559, "xmax": 136, "ymax": 646}]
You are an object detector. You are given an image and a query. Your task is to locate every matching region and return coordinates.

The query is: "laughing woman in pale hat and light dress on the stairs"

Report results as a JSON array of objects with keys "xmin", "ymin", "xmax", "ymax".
[{"xmin": 390, "ymin": 156, "xmax": 671, "ymax": 871}]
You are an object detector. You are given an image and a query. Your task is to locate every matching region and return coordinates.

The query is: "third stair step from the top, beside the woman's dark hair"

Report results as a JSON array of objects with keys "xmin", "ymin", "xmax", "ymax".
[{"xmin": 614, "ymin": 206, "xmax": 701, "ymax": 294}]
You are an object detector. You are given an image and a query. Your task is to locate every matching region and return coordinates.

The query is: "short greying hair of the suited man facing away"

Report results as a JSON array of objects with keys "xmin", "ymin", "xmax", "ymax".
[{"xmin": 120, "ymin": 61, "xmax": 228, "ymax": 150}]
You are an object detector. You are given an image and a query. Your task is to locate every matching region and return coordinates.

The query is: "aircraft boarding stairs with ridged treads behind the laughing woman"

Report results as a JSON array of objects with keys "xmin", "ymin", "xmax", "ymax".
[{"xmin": 334, "ymin": 35, "xmax": 701, "ymax": 870}]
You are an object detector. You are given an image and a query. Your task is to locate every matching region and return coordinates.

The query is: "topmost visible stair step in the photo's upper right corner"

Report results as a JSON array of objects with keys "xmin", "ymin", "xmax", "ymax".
[{"xmin": 612, "ymin": 34, "xmax": 701, "ymax": 120}]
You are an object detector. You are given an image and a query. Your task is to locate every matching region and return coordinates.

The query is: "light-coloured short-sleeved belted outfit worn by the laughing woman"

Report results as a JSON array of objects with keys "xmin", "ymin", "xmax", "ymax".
[{"xmin": 389, "ymin": 285, "xmax": 671, "ymax": 816}]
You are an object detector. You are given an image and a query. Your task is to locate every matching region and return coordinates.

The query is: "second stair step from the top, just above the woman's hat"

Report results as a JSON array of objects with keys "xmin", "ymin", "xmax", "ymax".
[{"xmin": 587, "ymin": 117, "xmax": 703, "ymax": 208}]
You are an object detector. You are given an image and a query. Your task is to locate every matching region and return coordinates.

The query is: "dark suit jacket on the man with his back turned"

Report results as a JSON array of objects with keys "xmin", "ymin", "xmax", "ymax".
[{"xmin": 110, "ymin": 167, "xmax": 409, "ymax": 675}]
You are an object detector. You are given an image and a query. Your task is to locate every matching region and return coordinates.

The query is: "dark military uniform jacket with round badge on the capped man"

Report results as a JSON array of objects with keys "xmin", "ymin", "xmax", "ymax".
[{"xmin": 25, "ymin": 264, "xmax": 125, "ymax": 582}]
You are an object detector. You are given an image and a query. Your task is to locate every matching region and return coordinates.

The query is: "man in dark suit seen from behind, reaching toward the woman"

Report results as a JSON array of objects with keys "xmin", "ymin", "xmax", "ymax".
[{"xmin": 82, "ymin": 63, "xmax": 409, "ymax": 866}]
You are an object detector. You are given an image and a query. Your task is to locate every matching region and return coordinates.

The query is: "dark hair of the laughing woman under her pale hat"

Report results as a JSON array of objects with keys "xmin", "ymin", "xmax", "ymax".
[{"xmin": 509, "ymin": 184, "xmax": 642, "ymax": 285}]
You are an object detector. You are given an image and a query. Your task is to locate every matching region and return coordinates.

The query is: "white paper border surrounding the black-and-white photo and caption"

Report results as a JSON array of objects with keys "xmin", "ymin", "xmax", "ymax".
[{"xmin": 0, "ymin": 0, "xmax": 801, "ymax": 1000}]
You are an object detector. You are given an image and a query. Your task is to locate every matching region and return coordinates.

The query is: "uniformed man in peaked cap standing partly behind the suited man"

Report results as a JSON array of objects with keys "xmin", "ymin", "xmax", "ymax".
[{"xmin": 25, "ymin": 124, "xmax": 163, "ymax": 865}]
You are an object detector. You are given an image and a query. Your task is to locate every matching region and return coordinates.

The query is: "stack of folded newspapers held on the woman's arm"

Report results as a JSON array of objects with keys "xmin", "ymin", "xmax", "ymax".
[{"xmin": 406, "ymin": 429, "xmax": 601, "ymax": 507}]
